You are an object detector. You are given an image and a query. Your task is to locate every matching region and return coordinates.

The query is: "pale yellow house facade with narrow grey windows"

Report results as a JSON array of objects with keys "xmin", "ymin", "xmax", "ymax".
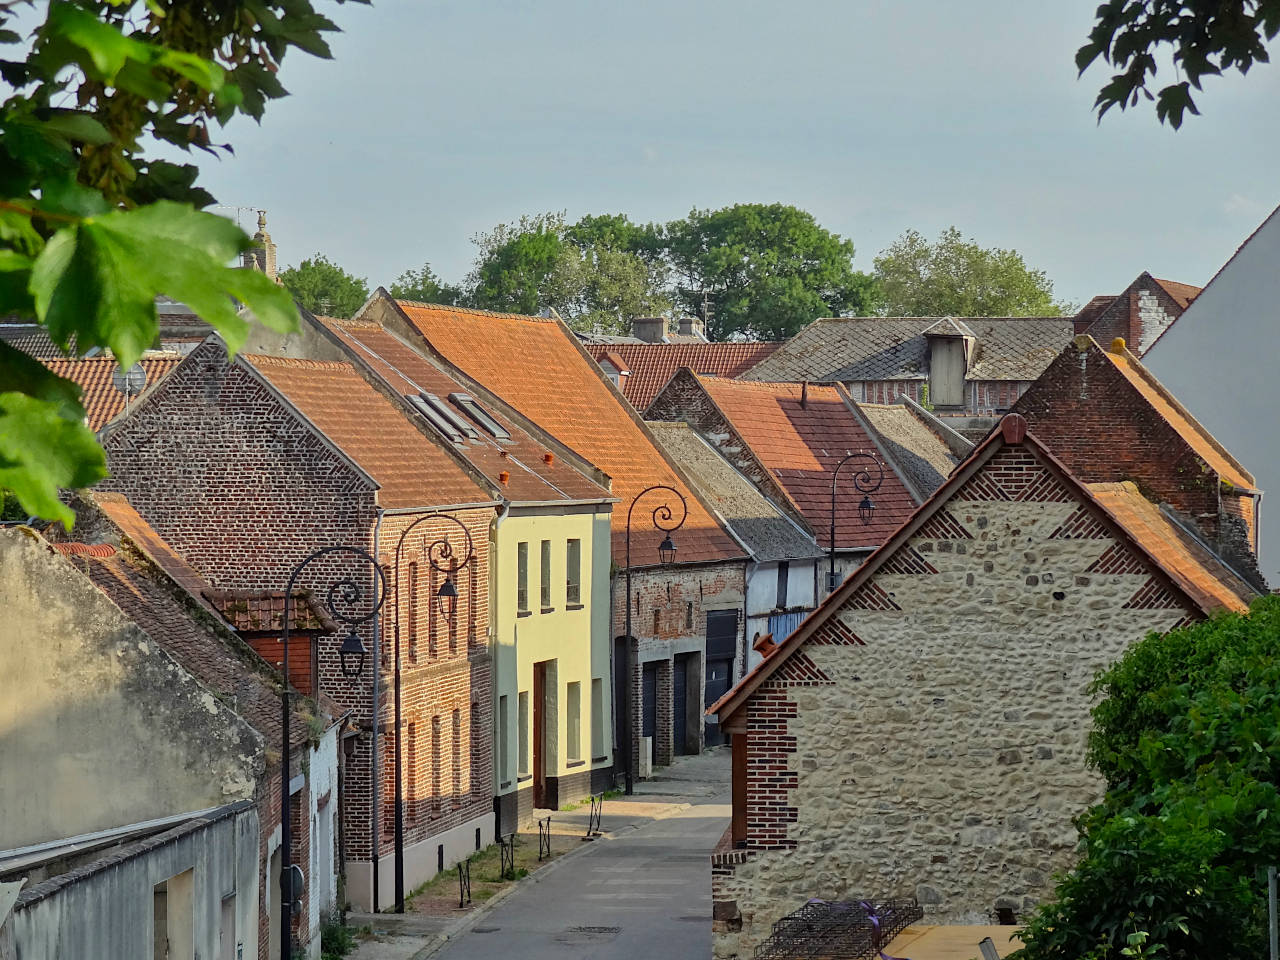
[{"xmin": 492, "ymin": 504, "xmax": 613, "ymax": 803}]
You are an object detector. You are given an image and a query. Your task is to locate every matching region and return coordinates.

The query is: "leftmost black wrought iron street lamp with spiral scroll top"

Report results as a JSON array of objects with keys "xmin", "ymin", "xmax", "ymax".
[{"xmin": 280, "ymin": 547, "xmax": 387, "ymax": 957}]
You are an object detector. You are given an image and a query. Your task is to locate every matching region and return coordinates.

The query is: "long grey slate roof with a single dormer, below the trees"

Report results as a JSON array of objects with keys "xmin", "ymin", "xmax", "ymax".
[{"xmin": 741, "ymin": 316, "xmax": 1074, "ymax": 383}]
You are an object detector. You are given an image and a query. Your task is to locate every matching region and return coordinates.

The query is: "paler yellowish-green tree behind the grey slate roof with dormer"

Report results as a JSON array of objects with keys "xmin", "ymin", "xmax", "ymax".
[{"xmin": 876, "ymin": 227, "xmax": 1074, "ymax": 316}]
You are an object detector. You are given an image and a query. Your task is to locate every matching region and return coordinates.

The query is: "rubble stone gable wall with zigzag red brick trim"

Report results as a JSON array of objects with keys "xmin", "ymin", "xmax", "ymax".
[{"xmin": 713, "ymin": 447, "xmax": 1196, "ymax": 960}]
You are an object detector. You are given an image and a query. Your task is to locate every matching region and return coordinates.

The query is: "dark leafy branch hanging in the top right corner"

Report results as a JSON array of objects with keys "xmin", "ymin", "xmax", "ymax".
[{"xmin": 1075, "ymin": 0, "xmax": 1280, "ymax": 129}]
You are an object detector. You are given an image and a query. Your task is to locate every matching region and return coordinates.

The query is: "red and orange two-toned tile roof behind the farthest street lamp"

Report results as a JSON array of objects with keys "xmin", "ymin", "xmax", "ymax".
[{"xmin": 698, "ymin": 376, "xmax": 916, "ymax": 549}]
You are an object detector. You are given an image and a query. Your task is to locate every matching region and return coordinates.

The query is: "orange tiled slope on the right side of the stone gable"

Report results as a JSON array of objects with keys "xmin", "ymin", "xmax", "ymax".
[{"xmin": 1088, "ymin": 480, "xmax": 1257, "ymax": 613}]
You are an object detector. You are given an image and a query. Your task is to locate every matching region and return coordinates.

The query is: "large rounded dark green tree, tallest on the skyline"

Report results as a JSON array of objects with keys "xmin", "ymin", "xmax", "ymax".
[{"xmin": 662, "ymin": 204, "xmax": 878, "ymax": 339}]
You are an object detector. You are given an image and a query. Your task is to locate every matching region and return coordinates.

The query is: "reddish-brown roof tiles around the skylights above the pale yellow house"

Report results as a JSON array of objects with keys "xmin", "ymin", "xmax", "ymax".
[{"xmin": 316, "ymin": 317, "xmax": 612, "ymax": 503}]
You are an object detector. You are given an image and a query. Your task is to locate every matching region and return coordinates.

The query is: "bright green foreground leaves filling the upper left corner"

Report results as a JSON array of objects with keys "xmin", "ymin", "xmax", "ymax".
[{"xmin": 0, "ymin": 0, "xmax": 360, "ymax": 526}]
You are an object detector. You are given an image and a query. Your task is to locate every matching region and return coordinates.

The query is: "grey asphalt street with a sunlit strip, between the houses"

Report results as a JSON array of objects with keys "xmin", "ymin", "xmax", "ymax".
[{"xmin": 347, "ymin": 746, "xmax": 730, "ymax": 960}]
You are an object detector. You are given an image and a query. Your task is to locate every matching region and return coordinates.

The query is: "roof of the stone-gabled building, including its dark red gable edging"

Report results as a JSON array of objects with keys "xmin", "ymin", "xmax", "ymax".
[{"xmin": 707, "ymin": 413, "xmax": 1257, "ymax": 724}]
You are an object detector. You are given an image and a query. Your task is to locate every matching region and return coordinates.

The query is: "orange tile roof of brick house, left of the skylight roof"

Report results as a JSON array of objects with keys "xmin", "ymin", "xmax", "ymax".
[{"xmin": 237, "ymin": 353, "xmax": 493, "ymax": 508}]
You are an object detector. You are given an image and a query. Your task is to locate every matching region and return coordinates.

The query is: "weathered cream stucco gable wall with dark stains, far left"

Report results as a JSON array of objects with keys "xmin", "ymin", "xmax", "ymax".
[{"xmin": 0, "ymin": 529, "xmax": 264, "ymax": 850}]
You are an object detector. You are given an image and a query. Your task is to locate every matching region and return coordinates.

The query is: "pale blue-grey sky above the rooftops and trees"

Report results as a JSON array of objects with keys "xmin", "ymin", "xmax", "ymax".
[{"xmin": 172, "ymin": 0, "xmax": 1280, "ymax": 303}]
